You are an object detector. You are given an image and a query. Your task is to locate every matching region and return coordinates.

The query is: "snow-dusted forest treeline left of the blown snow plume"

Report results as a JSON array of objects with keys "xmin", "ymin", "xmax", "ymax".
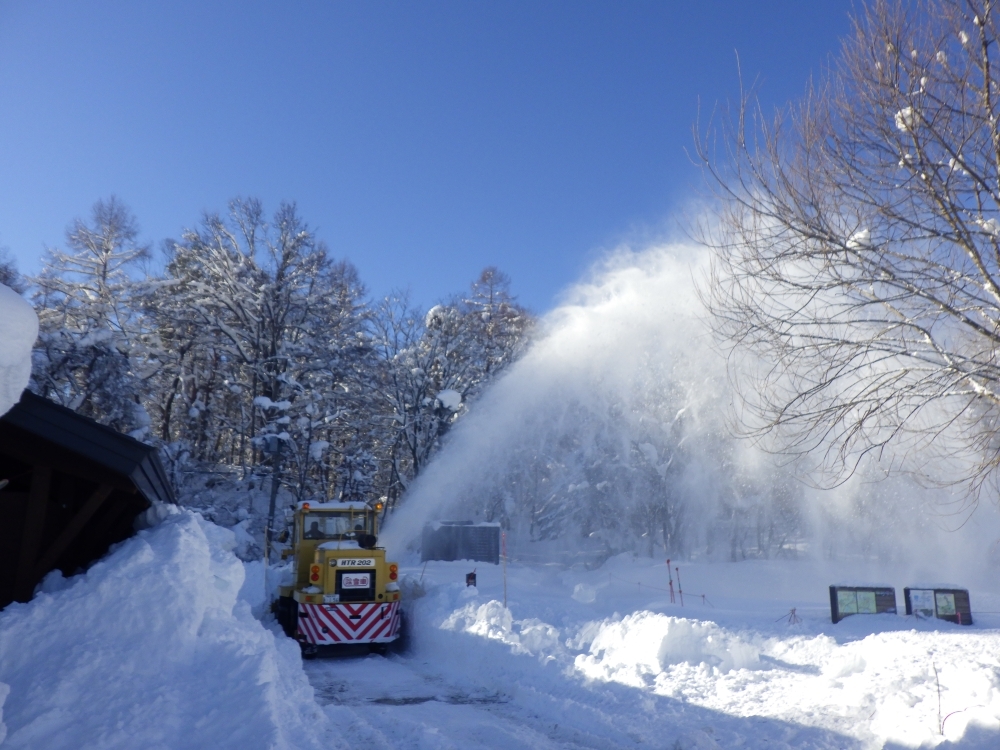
[{"xmin": 0, "ymin": 197, "xmax": 532, "ymax": 528}]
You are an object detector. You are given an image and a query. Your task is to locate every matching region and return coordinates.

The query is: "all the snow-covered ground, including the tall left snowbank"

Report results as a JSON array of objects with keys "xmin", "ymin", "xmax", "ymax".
[{"xmin": 0, "ymin": 512, "xmax": 1000, "ymax": 750}]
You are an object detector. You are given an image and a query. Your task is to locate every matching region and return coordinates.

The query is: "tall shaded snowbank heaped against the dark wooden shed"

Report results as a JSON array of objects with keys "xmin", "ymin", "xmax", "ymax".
[{"xmin": 0, "ymin": 511, "xmax": 328, "ymax": 750}]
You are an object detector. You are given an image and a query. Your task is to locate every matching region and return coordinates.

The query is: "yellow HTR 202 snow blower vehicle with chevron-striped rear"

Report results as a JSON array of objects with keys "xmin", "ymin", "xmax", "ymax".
[{"xmin": 275, "ymin": 503, "xmax": 402, "ymax": 657}]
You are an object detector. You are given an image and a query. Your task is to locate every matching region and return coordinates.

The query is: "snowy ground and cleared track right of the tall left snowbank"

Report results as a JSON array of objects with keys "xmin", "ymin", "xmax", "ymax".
[{"xmin": 306, "ymin": 556, "xmax": 1000, "ymax": 749}]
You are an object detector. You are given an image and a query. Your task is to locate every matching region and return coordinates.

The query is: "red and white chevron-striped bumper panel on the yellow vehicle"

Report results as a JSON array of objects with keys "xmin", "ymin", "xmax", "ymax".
[{"xmin": 298, "ymin": 602, "xmax": 400, "ymax": 646}]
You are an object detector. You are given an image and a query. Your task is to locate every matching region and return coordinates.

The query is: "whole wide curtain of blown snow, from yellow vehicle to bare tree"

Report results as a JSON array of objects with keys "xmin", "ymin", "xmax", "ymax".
[{"xmin": 382, "ymin": 244, "xmax": 996, "ymax": 570}]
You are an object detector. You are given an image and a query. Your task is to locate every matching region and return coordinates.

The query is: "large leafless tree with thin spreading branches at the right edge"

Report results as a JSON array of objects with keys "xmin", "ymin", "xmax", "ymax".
[{"xmin": 698, "ymin": 0, "xmax": 1000, "ymax": 506}]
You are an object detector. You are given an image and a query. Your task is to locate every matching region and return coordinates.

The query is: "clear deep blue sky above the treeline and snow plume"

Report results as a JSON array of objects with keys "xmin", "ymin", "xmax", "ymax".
[{"xmin": 0, "ymin": 0, "xmax": 851, "ymax": 312}]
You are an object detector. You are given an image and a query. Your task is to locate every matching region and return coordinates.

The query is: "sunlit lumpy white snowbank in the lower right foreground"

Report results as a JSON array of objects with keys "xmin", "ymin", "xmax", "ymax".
[{"xmin": 574, "ymin": 612, "xmax": 1000, "ymax": 747}]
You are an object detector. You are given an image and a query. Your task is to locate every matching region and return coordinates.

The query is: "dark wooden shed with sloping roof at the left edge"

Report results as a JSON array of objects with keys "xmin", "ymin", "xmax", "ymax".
[{"xmin": 0, "ymin": 391, "xmax": 174, "ymax": 608}]
